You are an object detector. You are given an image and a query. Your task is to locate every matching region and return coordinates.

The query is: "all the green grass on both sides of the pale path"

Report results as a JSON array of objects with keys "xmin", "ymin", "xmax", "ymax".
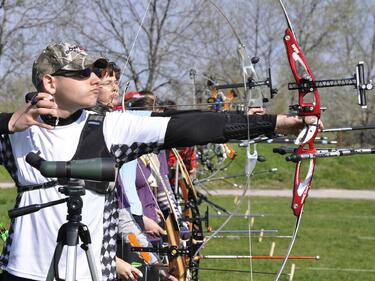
[{"xmin": 0, "ymin": 140, "xmax": 375, "ymax": 281}]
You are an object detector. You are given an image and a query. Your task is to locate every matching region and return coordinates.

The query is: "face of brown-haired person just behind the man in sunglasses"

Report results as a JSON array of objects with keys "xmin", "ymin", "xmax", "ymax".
[{"xmin": 98, "ymin": 75, "xmax": 119, "ymax": 108}]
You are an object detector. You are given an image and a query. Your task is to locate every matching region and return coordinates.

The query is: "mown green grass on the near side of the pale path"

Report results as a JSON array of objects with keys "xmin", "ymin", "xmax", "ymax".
[{"xmin": 0, "ymin": 189, "xmax": 375, "ymax": 281}]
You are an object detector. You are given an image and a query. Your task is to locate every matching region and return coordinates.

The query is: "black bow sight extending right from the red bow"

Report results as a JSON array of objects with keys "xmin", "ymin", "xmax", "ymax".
[{"xmin": 288, "ymin": 61, "xmax": 373, "ymax": 109}]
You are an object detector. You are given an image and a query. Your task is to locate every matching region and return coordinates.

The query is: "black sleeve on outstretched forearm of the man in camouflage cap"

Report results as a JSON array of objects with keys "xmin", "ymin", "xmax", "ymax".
[{"xmin": 163, "ymin": 112, "xmax": 276, "ymax": 148}]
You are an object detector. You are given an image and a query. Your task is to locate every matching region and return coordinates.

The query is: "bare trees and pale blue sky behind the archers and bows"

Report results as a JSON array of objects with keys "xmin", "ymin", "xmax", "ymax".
[{"xmin": 0, "ymin": 0, "xmax": 375, "ymax": 143}]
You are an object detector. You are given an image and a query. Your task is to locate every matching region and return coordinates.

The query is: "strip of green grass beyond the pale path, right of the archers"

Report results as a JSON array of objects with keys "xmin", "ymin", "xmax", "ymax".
[{"xmin": 197, "ymin": 144, "xmax": 375, "ymax": 189}]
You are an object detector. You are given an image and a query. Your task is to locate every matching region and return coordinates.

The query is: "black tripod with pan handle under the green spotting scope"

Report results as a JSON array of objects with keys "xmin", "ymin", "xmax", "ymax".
[{"xmin": 9, "ymin": 180, "xmax": 101, "ymax": 281}]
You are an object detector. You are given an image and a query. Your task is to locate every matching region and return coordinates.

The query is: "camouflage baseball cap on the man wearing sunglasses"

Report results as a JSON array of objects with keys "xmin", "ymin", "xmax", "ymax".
[{"xmin": 32, "ymin": 42, "xmax": 108, "ymax": 89}]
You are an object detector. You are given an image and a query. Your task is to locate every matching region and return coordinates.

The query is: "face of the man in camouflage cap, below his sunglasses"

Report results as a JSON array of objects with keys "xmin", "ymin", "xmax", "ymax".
[{"xmin": 53, "ymin": 72, "xmax": 101, "ymax": 112}]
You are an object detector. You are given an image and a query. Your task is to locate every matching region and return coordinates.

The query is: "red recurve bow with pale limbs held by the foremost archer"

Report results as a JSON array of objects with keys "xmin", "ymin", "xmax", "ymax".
[{"xmin": 275, "ymin": 0, "xmax": 320, "ymax": 281}]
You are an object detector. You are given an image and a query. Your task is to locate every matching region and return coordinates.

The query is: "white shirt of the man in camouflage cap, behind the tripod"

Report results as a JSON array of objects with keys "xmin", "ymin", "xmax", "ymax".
[{"xmin": 0, "ymin": 110, "xmax": 169, "ymax": 280}]
